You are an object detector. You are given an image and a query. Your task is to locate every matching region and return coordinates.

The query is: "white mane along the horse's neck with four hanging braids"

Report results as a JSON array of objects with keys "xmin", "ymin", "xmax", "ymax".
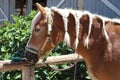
[{"xmin": 51, "ymin": 7, "xmax": 110, "ymax": 49}]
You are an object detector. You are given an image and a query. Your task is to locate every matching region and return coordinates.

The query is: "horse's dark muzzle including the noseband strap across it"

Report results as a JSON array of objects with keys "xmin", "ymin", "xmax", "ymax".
[{"xmin": 25, "ymin": 46, "xmax": 39, "ymax": 64}]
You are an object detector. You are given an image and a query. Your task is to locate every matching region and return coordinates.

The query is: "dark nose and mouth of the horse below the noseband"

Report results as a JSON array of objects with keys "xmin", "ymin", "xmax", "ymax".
[{"xmin": 25, "ymin": 50, "xmax": 39, "ymax": 64}]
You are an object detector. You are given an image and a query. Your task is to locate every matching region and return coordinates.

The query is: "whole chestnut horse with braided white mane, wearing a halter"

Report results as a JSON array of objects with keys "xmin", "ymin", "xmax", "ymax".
[{"xmin": 25, "ymin": 3, "xmax": 120, "ymax": 80}]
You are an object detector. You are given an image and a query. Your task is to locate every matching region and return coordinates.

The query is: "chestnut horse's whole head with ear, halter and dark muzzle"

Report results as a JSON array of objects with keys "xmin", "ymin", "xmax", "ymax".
[{"xmin": 25, "ymin": 3, "xmax": 54, "ymax": 63}]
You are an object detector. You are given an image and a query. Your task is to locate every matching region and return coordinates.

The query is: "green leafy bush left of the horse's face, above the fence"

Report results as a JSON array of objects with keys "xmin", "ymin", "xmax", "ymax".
[{"xmin": 0, "ymin": 11, "xmax": 36, "ymax": 60}]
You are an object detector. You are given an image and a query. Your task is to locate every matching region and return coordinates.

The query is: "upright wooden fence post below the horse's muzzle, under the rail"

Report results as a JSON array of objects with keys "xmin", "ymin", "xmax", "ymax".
[{"xmin": 22, "ymin": 65, "xmax": 35, "ymax": 80}]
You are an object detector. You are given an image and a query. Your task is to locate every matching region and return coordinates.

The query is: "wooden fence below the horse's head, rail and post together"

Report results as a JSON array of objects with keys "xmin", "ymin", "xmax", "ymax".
[{"xmin": 0, "ymin": 54, "xmax": 83, "ymax": 80}]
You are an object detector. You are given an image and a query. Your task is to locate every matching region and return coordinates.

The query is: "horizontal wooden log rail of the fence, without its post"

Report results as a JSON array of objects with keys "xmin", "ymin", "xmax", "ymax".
[{"xmin": 0, "ymin": 54, "xmax": 83, "ymax": 72}]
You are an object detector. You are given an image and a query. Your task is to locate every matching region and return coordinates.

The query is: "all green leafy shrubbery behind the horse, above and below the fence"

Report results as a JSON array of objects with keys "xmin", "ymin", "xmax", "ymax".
[{"xmin": 0, "ymin": 11, "xmax": 89, "ymax": 80}]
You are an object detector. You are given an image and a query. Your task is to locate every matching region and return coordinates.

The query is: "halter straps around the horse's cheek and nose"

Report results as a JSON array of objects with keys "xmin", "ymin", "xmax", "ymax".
[{"xmin": 25, "ymin": 8, "xmax": 55, "ymax": 55}]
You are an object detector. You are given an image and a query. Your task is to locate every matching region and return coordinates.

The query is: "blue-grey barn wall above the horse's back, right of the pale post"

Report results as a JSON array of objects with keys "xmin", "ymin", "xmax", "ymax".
[{"xmin": 83, "ymin": 0, "xmax": 120, "ymax": 18}]
